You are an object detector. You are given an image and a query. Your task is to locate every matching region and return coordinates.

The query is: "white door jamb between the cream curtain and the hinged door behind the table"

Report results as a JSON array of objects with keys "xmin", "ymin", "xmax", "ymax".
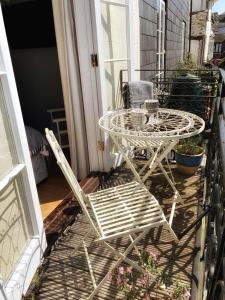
[{"xmin": 73, "ymin": 0, "xmax": 104, "ymax": 171}]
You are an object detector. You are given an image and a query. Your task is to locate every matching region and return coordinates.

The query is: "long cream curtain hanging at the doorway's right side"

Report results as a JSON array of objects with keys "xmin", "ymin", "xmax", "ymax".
[{"xmin": 52, "ymin": 0, "xmax": 89, "ymax": 179}]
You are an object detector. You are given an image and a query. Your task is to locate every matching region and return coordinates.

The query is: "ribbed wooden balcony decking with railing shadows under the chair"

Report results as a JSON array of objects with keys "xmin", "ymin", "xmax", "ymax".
[{"xmin": 28, "ymin": 168, "xmax": 202, "ymax": 300}]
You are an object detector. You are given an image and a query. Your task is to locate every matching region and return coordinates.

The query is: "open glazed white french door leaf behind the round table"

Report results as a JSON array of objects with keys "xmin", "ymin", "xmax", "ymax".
[{"xmin": 96, "ymin": 0, "xmax": 134, "ymax": 110}]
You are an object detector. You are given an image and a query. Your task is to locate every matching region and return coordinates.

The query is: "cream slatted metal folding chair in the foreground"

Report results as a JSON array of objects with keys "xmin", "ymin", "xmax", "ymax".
[{"xmin": 45, "ymin": 129, "xmax": 177, "ymax": 299}]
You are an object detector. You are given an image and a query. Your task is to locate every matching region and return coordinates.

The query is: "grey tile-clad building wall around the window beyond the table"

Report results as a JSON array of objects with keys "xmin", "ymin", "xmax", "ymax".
[{"xmin": 139, "ymin": 0, "xmax": 190, "ymax": 79}]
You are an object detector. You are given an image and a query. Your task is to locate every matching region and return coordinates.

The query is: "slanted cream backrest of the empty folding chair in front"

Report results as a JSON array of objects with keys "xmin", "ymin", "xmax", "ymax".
[{"xmin": 45, "ymin": 128, "xmax": 99, "ymax": 235}]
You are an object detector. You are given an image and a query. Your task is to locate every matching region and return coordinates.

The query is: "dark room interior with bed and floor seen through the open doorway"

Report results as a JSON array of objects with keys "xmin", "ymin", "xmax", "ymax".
[{"xmin": 2, "ymin": 0, "xmax": 69, "ymax": 219}]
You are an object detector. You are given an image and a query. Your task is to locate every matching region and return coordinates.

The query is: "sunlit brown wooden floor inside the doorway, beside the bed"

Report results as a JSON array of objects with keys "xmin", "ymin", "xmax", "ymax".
[{"xmin": 37, "ymin": 168, "xmax": 70, "ymax": 220}]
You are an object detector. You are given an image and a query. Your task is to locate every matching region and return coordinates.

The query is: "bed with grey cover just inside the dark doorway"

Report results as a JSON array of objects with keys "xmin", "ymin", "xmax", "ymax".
[{"xmin": 25, "ymin": 126, "xmax": 49, "ymax": 184}]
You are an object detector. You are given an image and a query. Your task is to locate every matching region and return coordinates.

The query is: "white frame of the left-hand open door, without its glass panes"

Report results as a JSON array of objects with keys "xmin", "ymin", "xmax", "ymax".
[{"xmin": 0, "ymin": 7, "xmax": 47, "ymax": 299}]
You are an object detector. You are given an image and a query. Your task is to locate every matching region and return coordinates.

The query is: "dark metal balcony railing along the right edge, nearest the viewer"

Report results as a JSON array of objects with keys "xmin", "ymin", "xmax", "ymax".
[{"xmin": 204, "ymin": 70, "xmax": 225, "ymax": 300}]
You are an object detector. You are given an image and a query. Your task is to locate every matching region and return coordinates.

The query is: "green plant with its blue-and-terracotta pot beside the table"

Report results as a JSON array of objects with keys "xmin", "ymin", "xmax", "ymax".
[{"xmin": 175, "ymin": 139, "xmax": 204, "ymax": 175}]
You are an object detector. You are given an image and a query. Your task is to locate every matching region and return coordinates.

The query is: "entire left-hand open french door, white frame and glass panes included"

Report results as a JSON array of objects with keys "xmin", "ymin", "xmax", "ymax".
[{"xmin": 0, "ymin": 8, "xmax": 46, "ymax": 299}]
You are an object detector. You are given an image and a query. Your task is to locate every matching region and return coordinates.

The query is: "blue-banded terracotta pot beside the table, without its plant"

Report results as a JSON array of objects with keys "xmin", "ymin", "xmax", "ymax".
[{"xmin": 175, "ymin": 151, "xmax": 204, "ymax": 175}]
